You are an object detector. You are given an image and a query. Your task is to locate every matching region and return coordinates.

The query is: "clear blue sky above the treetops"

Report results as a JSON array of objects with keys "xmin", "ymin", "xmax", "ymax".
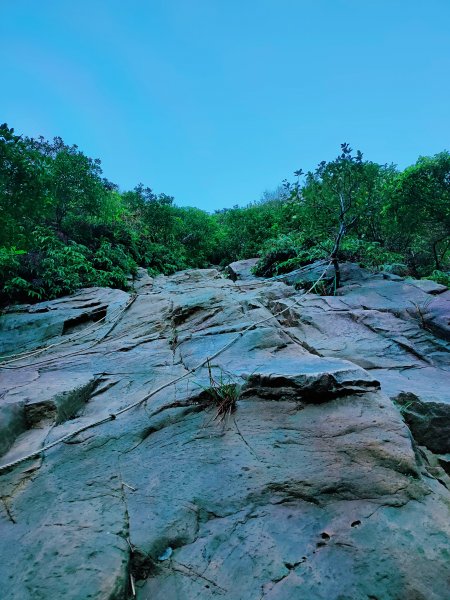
[{"xmin": 0, "ymin": 0, "xmax": 450, "ymax": 210}]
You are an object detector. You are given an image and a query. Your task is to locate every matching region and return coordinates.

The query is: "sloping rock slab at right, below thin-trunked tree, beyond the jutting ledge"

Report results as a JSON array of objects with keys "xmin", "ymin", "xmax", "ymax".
[{"xmin": 265, "ymin": 265, "xmax": 450, "ymax": 453}]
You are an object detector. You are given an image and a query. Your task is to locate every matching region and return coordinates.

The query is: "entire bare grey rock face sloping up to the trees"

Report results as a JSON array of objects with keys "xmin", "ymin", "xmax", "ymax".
[{"xmin": 0, "ymin": 265, "xmax": 450, "ymax": 600}]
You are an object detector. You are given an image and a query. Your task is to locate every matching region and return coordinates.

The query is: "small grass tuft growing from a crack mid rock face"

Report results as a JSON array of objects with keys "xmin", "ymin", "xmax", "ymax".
[{"xmin": 196, "ymin": 360, "xmax": 241, "ymax": 423}]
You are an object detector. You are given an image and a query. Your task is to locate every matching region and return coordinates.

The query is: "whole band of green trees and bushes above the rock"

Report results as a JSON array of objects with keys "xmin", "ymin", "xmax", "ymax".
[{"xmin": 0, "ymin": 124, "xmax": 450, "ymax": 303}]
